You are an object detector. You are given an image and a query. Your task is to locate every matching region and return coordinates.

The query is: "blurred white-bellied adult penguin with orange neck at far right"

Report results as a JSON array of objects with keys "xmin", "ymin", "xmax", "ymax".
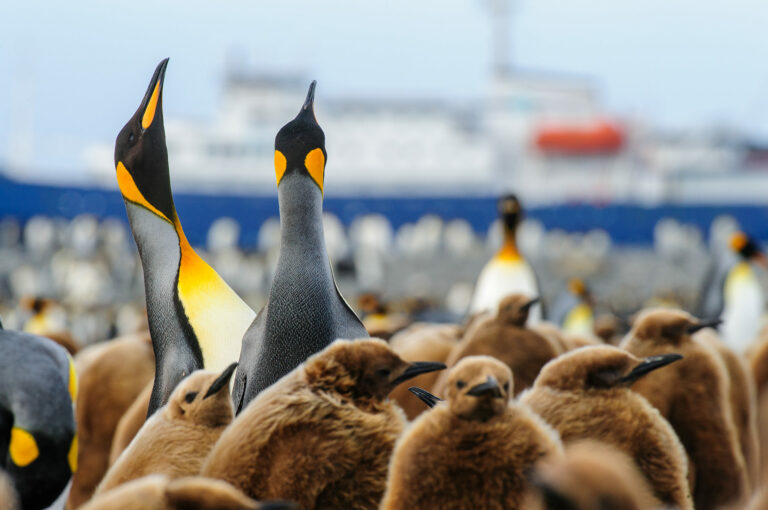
[{"xmin": 696, "ymin": 232, "xmax": 768, "ymax": 353}]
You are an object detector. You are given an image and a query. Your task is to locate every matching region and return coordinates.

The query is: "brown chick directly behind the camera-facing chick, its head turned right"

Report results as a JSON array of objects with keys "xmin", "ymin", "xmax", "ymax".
[{"xmin": 433, "ymin": 294, "xmax": 559, "ymax": 396}]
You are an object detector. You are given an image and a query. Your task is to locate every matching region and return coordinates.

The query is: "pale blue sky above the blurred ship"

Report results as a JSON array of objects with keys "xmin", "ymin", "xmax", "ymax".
[{"xmin": 0, "ymin": 0, "xmax": 768, "ymax": 171}]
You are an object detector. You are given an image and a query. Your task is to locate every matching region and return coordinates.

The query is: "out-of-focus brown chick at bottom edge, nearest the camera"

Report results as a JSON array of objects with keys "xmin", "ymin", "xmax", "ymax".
[{"xmin": 527, "ymin": 440, "xmax": 659, "ymax": 510}]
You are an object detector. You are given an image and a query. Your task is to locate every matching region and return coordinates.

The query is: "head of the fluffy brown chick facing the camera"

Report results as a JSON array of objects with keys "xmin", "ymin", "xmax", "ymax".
[{"xmin": 446, "ymin": 356, "xmax": 514, "ymax": 421}]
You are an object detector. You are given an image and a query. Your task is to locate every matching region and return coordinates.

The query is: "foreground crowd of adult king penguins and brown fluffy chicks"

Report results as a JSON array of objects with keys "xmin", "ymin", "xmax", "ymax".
[{"xmin": 0, "ymin": 59, "xmax": 768, "ymax": 510}]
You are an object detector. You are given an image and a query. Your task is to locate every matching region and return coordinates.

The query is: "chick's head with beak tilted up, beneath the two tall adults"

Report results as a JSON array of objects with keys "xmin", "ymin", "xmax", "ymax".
[{"xmin": 166, "ymin": 363, "xmax": 237, "ymax": 427}]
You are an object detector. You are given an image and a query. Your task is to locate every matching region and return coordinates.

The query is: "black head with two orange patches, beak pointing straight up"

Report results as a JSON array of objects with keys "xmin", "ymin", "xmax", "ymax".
[{"xmin": 275, "ymin": 81, "xmax": 328, "ymax": 193}]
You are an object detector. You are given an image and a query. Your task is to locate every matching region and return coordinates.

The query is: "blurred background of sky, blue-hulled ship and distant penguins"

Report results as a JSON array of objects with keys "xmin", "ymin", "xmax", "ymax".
[{"xmin": 0, "ymin": 0, "xmax": 768, "ymax": 343}]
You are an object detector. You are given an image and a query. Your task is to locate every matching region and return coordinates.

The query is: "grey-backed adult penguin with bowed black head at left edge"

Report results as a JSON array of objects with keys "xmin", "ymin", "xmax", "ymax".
[{"xmin": 0, "ymin": 330, "xmax": 77, "ymax": 510}]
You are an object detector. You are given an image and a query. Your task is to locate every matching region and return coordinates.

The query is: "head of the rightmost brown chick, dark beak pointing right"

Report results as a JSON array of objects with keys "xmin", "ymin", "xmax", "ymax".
[{"xmin": 628, "ymin": 308, "xmax": 720, "ymax": 345}]
